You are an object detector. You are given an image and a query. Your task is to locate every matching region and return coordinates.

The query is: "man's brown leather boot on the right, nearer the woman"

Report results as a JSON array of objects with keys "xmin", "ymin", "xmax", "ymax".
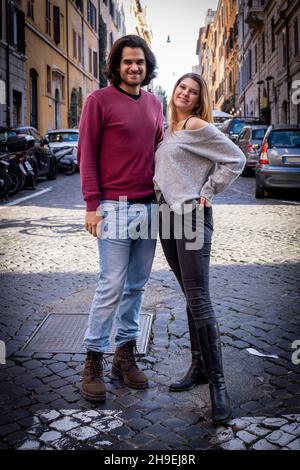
[{"xmin": 110, "ymin": 339, "xmax": 148, "ymax": 390}]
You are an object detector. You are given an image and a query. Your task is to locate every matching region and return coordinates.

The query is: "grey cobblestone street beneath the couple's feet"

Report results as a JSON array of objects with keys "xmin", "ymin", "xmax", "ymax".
[{"xmin": 0, "ymin": 173, "xmax": 300, "ymax": 450}]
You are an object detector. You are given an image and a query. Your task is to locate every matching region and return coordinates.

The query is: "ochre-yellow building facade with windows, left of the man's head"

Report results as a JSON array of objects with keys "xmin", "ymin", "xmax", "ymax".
[{"xmin": 25, "ymin": 0, "xmax": 99, "ymax": 134}]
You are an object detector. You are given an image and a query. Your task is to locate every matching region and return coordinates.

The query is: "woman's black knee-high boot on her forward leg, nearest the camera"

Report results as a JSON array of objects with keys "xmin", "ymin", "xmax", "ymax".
[{"xmin": 197, "ymin": 322, "xmax": 231, "ymax": 424}]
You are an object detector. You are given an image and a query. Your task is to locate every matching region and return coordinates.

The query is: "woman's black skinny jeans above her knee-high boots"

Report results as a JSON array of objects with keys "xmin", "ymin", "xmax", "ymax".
[{"xmin": 159, "ymin": 197, "xmax": 216, "ymax": 329}]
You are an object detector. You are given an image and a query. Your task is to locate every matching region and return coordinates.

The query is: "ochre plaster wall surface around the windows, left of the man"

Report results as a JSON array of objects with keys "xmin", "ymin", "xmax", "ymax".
[{"xmin": 25, "ymin": 0, "xmax": 99, "ymax": 135}]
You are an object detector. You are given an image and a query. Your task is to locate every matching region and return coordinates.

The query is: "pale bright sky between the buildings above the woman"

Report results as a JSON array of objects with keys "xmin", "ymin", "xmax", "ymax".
[{"xmin": 142, "ymin": 0, "xmax": 218, "ymax": 97}]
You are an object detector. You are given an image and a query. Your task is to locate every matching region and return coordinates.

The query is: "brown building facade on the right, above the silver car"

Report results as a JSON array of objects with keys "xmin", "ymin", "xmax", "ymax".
[{"xmin": 238, "ymin": 0, "xmax": 300, "ymax": 124}]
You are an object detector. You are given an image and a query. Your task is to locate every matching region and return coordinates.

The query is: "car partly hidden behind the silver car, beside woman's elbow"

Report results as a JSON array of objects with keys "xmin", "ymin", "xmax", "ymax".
[{"xmin": 235, "ymin": 124, "xmax": 268, "ymax": 176}]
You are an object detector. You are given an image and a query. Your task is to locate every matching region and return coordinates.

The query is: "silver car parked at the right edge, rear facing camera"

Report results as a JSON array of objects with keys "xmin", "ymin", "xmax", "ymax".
[{"xmin": 255, "ymin": 125, "xmax": 300, "ymax": 198}]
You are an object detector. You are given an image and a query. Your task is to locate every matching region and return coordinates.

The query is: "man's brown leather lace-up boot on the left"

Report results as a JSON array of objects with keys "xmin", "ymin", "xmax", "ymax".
[{"xmin": 81, "ymin": 351, "xmax": 106, "ymax": 402}]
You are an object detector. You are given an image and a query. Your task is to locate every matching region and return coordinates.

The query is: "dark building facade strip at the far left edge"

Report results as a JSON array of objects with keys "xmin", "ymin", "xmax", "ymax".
[{"xmin": 0, "ymin": 0, "xmax": 26, "ymax": 127}]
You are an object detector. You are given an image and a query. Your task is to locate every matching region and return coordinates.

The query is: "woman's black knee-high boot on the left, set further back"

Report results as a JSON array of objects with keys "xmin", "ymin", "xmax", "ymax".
[{"xmin": 169, "ymin": 307, "xmax": 208, "ymax": 392}]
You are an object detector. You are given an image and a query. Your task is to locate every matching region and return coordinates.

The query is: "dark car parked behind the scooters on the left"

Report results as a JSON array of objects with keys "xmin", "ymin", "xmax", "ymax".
[{"xmin": 16, "ymin": 126, "xmax": 57, "ymax": 180}]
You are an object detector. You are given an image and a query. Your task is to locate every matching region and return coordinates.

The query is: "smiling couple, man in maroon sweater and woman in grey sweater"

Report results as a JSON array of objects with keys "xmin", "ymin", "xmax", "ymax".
[{"xmin": 78, "ymin": 35, "xmax": 245, "ymax": 424}]
